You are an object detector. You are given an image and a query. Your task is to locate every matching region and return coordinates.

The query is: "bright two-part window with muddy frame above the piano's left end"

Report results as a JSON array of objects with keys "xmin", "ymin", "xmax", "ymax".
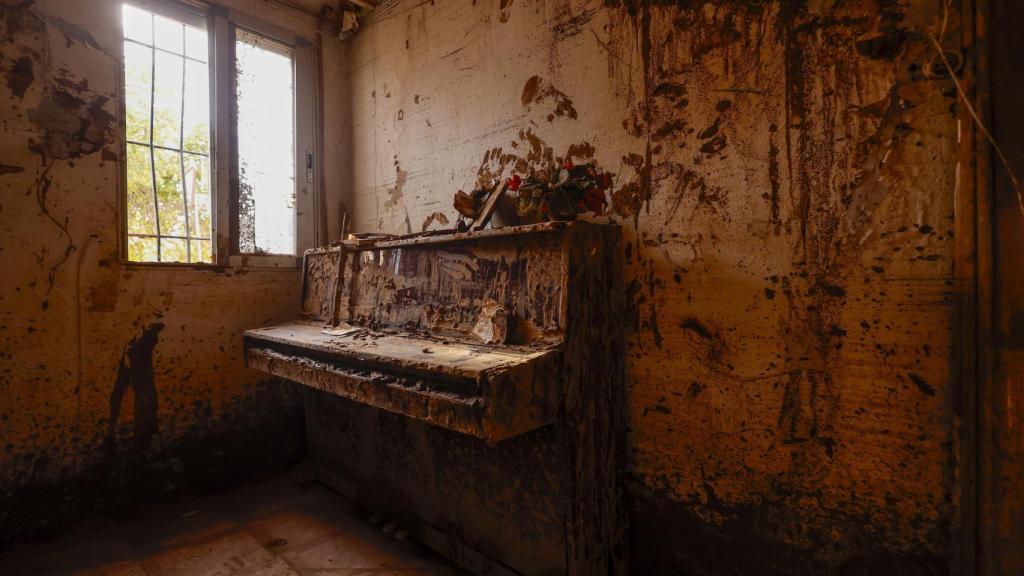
[{"xmin": 122, "ymin": 0, "xmax": 315, "ymax": 265}]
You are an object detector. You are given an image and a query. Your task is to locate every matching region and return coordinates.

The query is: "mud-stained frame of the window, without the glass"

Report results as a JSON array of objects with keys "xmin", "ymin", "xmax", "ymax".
[{"xmin": 118, "ymin": 0, "xmax": 321, "ymax": 269}]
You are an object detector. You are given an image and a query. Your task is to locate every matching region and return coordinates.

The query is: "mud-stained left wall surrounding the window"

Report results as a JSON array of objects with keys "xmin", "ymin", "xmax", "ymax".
[{"xmin": 0, "ymin": 0, "xmax": 342, "ymax": 539}]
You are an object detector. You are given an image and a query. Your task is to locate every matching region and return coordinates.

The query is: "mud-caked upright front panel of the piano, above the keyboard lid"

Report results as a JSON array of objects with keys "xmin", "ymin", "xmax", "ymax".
[{"xmin": 339, "ymin": 234, "xmax": 564, "ymax": 343}]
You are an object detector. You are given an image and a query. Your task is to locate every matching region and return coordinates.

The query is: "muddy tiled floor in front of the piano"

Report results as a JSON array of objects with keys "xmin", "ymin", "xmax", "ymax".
[{"xmin": 0, "ymin": 479, "xmax": 463, "ymax": 576}]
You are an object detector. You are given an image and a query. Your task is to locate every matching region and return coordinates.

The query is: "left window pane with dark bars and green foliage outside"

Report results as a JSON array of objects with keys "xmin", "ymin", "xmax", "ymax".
[{"xmin": 124, "ymin": 1, "xmax": 213, "ymax": 262}]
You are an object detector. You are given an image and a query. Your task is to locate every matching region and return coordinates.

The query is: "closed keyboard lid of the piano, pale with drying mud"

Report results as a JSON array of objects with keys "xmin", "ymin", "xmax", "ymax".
[{"xmin": 245, "ymin": 320, "xmax": 557, "ymax": 381}]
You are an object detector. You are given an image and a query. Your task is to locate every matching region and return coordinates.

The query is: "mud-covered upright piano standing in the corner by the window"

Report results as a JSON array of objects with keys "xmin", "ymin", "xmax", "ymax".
[{"xmin": 245, "ymin": 221, "xmax": 627, "ymax": 575}]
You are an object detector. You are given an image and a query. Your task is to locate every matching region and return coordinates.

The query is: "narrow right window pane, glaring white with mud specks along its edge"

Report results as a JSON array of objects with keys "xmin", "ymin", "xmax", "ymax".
[{"xmin": 234, "ymin": 30, "xmax": 295, "ymax": 254}]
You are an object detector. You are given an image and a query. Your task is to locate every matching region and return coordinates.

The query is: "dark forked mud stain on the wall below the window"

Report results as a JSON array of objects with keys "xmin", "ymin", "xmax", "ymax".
[{"xmin": 106, "ymin": 322, "xmax": 164, "ymax": 456}]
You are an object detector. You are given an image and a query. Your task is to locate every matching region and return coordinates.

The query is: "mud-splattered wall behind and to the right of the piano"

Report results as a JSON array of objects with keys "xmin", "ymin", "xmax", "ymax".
[{"xmin": 346, "ymin": 0, "xmax": 958, "ymax": 574}]
